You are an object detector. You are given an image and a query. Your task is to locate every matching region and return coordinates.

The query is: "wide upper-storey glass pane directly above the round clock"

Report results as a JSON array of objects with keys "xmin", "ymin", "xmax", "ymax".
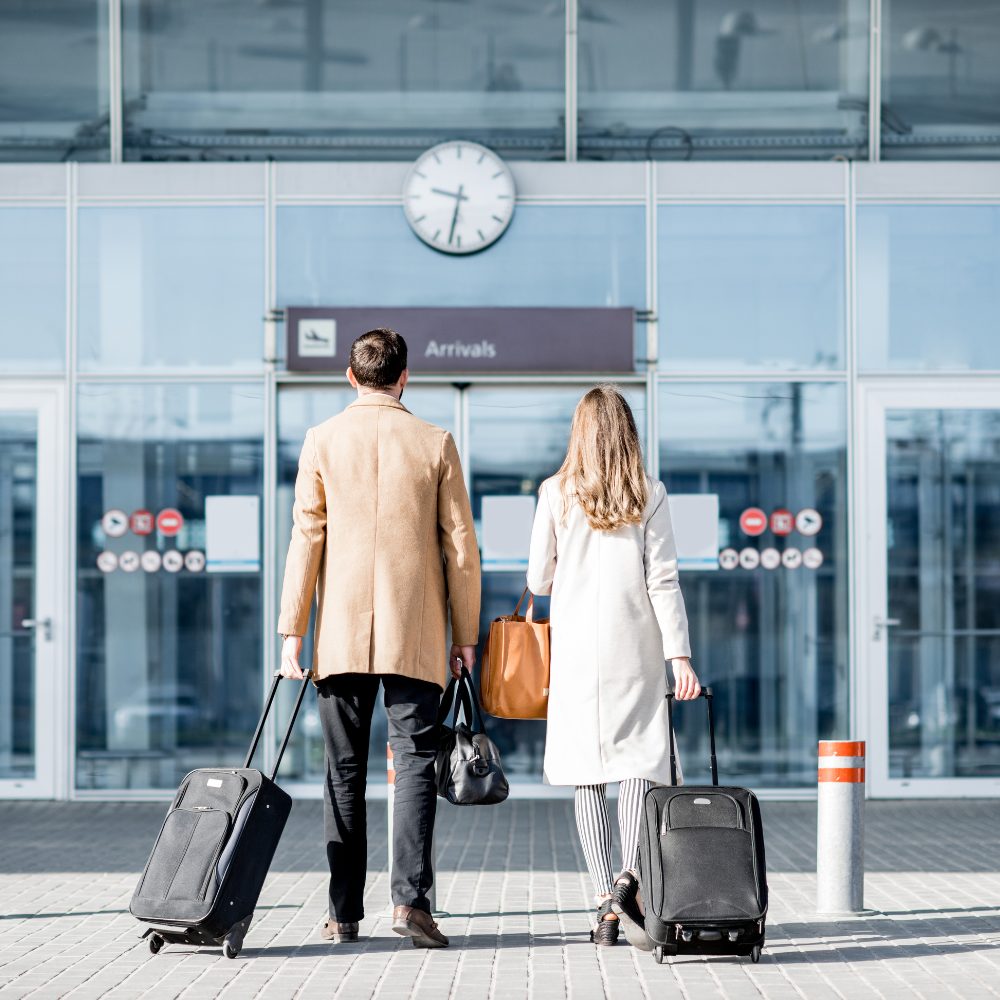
[{"xmin": 124, "ymin": 0, "xmax": 565, "ymax": 160}]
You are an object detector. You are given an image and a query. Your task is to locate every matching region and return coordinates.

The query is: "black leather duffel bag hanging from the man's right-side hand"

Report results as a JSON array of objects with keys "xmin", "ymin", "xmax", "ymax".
[{"xmin": 435, "ymin": 667, "xmax": 510, "ymax": 806}]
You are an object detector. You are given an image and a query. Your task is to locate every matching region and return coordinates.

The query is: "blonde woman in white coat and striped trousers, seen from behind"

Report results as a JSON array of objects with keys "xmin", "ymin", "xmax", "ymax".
[{"xmin": 528, "ymin": 385, "xmax": 701, "ymax": 949}]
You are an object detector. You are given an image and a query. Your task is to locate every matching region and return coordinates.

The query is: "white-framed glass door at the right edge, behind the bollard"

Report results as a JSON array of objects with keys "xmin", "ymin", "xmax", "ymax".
[{"xmin": 857, "ymin": 379, "xmax": 1000, "ymax": 797}]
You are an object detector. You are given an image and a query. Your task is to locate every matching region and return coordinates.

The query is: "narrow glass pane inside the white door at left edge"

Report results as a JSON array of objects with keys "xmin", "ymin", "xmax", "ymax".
[{"xmin": 0, "ymin": 412, "xmax": 38, "ymax": 779}]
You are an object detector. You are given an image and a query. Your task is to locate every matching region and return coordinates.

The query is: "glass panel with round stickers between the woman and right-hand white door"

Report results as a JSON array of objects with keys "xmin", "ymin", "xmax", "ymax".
[{"xmin": 660, "ymin": 383, "xmax": 848, "ymax": 787}]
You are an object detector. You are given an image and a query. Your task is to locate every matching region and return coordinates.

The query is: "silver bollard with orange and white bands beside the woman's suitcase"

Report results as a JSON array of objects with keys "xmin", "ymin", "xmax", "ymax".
[{"xmin": 816, "ymin": 740, "xmax": 865, "ymax": 913}]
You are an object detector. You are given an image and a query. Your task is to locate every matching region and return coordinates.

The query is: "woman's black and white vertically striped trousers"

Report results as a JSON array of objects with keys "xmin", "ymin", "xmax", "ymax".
[{"xmin": 574, "ymin": 778, "xmax": 652, "ymax": 896}]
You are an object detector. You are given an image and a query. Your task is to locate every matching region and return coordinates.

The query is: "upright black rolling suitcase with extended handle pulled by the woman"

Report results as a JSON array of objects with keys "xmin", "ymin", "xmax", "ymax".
[{"xmin": 639, "ymin": 688, "xmax": 767, "ymax": 962}]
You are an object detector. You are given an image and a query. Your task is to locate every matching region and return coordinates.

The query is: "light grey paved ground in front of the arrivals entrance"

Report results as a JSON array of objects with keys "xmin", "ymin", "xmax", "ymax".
[{"xmin": 0, "ymin": 800, "xmax": 1000, "ymax": 1000}]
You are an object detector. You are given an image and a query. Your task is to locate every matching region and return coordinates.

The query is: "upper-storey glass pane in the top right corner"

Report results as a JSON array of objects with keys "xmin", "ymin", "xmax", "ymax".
[{"xmin": 882, "ymin": 0, "xmax": 1000, "ymax": 160}]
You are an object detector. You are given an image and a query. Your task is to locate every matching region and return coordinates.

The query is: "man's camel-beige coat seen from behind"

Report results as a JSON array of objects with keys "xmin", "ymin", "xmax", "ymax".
[{"xmin": 278, "ymin": 393, "xmax": 480, "ymax": 687}]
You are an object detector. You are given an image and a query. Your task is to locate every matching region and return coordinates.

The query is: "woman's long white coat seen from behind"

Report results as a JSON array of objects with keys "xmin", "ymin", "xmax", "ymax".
[{"xmin": 528, "ymin": 478, "xmax": 691, "ymax": 785}]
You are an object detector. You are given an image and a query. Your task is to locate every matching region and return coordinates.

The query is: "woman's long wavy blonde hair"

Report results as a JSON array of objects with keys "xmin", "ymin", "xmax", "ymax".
[{"xmin": 556, "ymin": 383, "xmax": 649, "ymax": 531}]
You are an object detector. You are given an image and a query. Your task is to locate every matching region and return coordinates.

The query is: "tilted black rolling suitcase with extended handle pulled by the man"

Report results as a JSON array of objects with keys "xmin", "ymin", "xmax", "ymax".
[{"xmin": 129, "ymin": 673, "xmax": 309, "ymax": 958}]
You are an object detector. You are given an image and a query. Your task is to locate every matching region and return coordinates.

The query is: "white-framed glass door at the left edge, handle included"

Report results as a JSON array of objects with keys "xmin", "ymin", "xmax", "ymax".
[{"xmin": 0, "ymin": 386, "xmax": 69, "ymax": 798}]
